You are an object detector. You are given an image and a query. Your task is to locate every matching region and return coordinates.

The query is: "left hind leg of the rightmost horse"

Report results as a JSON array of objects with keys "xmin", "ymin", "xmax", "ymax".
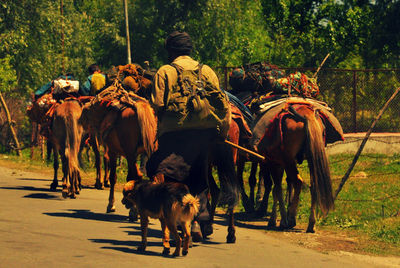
[{"xmin": 285, "ymin": 161, "xmax": 303, "ymax": 228}]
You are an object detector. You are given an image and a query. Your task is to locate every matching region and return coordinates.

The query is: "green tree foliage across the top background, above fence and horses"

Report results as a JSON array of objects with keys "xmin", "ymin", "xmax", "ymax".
[{"xmin": 0, "ymin": 0, "xmax": 400, "ymax": 96}]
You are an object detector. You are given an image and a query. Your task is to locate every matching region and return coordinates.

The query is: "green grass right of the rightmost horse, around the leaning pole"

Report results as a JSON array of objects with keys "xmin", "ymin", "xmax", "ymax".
[{"xmin": 292, "ymin": 154, "xmax": 400, "ymax": 256}]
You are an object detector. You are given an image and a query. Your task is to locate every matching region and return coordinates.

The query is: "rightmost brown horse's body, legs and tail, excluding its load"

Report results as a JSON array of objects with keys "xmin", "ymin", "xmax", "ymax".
[{"xmin": 257, "ymin": 103, "xmax": 334, "ymax": 232}]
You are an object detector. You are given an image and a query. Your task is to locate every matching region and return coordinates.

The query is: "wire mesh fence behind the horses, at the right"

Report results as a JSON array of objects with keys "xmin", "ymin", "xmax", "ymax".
[{"xmin": 217, "ymin": 67, "xmax": 400, "ymax": 133}]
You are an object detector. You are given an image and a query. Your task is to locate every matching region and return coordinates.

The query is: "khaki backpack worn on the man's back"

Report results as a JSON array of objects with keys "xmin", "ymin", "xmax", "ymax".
[{"xmin": 164, "ymin": 64, "xmax": 230, "ymax": 135}]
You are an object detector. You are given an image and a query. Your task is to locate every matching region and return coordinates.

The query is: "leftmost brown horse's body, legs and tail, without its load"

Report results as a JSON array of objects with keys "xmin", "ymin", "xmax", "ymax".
[{"xmin": 50, "ymin": 99, "xmax": 83, "ymax": 198}]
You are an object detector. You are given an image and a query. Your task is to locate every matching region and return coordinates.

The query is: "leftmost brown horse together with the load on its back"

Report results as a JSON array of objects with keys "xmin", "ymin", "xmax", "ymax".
[{"xmin": 27, "ymin": 76, "xmax": 83, "ymax": 198}]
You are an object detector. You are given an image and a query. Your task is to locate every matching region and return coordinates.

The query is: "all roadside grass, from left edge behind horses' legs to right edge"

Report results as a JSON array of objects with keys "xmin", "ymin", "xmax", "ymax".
[{"xmin": 0, "ymin": 149, "xmax": 400, "ymax": 256}]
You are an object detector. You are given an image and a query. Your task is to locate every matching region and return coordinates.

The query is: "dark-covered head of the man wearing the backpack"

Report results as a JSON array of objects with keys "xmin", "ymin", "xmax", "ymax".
[{"xmin": 165, "ymin": 31, "xmax": 193, "ymax": 56}]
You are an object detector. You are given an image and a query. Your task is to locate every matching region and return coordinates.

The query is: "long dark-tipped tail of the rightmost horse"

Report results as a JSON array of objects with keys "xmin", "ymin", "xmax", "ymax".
[{"xmin": 305, "ymin": 108, "xmax": 334, "ymax": 215}]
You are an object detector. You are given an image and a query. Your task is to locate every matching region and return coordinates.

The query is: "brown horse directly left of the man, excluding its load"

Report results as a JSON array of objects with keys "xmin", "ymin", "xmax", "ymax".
[{"xmin": 81, "ymin": 97, "xmax": 157, "ymax": 212}]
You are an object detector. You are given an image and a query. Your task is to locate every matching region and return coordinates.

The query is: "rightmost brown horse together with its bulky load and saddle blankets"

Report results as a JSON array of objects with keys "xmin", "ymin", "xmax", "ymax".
[{"xmin": 230, "ymin": 63, "xmax": 343, "ymax": 232}]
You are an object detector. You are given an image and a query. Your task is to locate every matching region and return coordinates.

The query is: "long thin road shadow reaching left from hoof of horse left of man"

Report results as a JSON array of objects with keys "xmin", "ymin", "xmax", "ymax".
[{"xmin": 43, "ymin": 209, "xmax": 128, "ymax": 222}]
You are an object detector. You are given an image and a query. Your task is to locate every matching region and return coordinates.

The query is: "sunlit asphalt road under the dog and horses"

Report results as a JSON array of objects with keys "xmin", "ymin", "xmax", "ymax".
[{"xmin": 0, "ymin": 167, "xmax": 394, "ymax": 268}]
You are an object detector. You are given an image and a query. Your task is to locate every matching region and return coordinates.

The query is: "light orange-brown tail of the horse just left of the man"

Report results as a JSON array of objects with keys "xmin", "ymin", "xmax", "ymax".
[{"xmin": 136, "ymin": 101, "xmax": 157, "ymax": 156}]
